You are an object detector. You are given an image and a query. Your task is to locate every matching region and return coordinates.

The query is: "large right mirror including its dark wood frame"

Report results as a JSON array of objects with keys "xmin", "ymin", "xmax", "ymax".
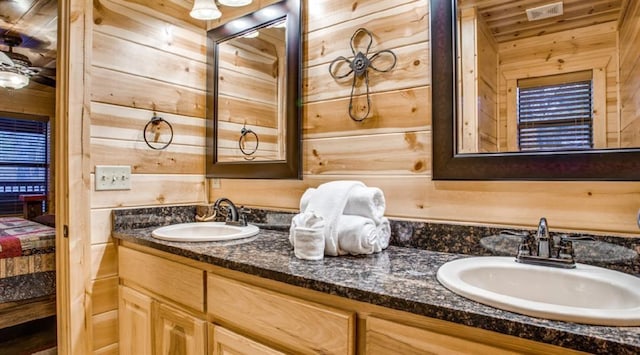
[{"xmin": 430, "ymin": 0, "xmax": 640, "ymax": 181}]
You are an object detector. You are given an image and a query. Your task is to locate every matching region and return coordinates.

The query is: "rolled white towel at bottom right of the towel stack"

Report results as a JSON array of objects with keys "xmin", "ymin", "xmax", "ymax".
[{"xmin": 338, "ymin": 215, "xmax": 379, "ymax": 255}]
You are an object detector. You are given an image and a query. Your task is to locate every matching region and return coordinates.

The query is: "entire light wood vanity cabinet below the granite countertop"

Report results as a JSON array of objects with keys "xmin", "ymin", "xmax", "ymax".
[{"xmin": 119, "ymin": 243, "xmax": 578, "ymax": 355}]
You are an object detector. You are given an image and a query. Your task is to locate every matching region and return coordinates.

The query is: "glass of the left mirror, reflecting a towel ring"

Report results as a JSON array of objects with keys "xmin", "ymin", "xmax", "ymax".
[{"xmin": 216, "ymin": 19, "xmax": 287, "ymax": 162}]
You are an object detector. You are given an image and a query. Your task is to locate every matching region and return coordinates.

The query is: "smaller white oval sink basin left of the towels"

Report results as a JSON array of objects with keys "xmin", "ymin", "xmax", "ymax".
[{"xmin": 151, "ymin": 222, "xmax": 260, "ymax": 242}]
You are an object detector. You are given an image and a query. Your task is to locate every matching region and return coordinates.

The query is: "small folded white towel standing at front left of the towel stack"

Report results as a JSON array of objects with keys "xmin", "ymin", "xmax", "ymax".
[{"xmin": 289, "ymin": 212, "xmax": 325, "ymax": 260}]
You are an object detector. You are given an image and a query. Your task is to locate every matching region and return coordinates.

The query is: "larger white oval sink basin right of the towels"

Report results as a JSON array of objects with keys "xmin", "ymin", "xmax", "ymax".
[{"xmin": 437, "ymin": 257, "xmax": 640, "ymax": 326}]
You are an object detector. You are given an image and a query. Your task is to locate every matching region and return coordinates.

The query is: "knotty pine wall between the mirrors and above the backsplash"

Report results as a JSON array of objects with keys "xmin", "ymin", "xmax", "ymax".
[{"xmin": 208, "ymin": 0, "xmax": 640, "ymax": 239}]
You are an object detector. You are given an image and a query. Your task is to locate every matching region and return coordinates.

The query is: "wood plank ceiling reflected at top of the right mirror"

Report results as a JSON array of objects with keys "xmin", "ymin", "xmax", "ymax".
[{"xmin": 458, "ymin": 0, "xmax": 624, "ymax": 42}]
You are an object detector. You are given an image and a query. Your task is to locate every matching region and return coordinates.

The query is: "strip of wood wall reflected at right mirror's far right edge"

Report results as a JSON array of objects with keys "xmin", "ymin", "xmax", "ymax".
[{"xmin": 619, "ymin": 1, "xmax": 640, "ymax": 147}]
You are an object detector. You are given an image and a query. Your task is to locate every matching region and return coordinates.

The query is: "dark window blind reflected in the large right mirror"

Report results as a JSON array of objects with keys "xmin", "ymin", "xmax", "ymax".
[{"xmin": 518, "ymin": 80, "xmax": 593, "ymax": 151}]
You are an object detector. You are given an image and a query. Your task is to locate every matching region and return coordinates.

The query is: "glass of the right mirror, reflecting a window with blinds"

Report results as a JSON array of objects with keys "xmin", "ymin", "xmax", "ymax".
[{"xmin": 455, "ymin": 0, "xmax": 640, "ymax": 154}]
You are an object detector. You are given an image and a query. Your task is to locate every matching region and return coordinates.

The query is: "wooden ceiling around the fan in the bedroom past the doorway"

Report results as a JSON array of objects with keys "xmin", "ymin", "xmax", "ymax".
[{"xmin": 0, "ymin": 0, "xmax": 58, "ymax": 87}]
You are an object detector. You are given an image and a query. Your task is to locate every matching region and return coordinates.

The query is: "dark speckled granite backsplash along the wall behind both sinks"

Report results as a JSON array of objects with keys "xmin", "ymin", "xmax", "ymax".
[{"xmin": 113, "ymin": 206, "xmax": 640, "ymax": 277}]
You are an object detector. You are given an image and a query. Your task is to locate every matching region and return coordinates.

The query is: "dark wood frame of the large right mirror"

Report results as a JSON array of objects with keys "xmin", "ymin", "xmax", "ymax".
[{"xmin": 430, "ymin": 0, "xmax": 640, "ymax": 181}]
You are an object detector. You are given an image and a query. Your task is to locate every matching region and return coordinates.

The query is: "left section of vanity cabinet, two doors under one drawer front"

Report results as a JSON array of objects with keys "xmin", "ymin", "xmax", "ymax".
[{"xmin": 118, "ymin": 247, "xmax": 207, "ymax": 355}]
